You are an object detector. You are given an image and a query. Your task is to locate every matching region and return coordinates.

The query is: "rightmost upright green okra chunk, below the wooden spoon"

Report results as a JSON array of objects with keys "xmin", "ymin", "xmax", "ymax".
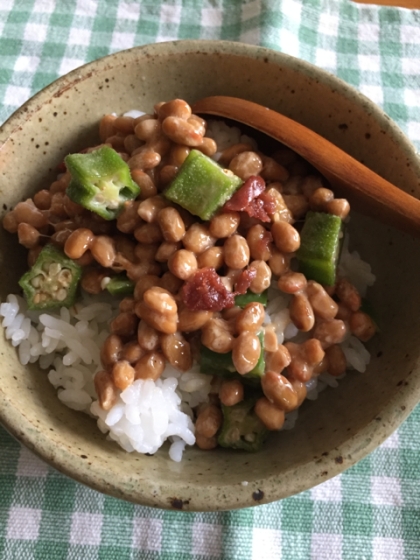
[{"xmin": 296, "ymin": 212, "xmax": 342, "ymax": 286}]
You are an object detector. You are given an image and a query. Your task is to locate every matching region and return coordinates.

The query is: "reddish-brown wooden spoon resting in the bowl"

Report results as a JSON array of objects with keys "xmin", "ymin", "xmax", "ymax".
[{"xmin": 192, "ymin": 96, "xmax": 420, "ymax": 236}]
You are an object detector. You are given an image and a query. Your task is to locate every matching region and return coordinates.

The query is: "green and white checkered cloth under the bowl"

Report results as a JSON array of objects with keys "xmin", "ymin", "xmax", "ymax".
[{"xmin": 0, "ymin": 0, "xmax": 420, "ymax": 560}]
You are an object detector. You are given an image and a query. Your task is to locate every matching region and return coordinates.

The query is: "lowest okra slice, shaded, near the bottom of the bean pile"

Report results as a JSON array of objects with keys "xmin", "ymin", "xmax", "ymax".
[{"xmin": 217, "ymin": 399, "xmax": 268, "ymax": 452}]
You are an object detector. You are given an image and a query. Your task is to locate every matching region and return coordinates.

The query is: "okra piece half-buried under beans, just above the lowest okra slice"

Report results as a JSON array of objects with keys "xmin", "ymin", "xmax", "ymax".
[{"xmin": 200, "ymin": 331, "xmax": 265, "ymax": 385}]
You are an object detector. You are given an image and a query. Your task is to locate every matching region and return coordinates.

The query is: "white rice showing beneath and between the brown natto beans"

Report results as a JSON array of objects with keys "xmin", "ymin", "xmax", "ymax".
[{"xmin": 0, "ymin": 236, "xmax": 374, "ymax": 461}]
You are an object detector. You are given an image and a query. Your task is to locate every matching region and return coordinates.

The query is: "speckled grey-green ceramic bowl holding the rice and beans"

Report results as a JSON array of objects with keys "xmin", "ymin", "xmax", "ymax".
[{"xmin": 0, "ymin": 41, "xmax": 420, "ymax": 511}]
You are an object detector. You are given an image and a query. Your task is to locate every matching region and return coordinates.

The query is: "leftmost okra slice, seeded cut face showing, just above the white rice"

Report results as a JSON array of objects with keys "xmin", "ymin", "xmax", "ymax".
[{"xmin": 19, "ymin": 245, "xmax": 82, "ymax": 309}]
